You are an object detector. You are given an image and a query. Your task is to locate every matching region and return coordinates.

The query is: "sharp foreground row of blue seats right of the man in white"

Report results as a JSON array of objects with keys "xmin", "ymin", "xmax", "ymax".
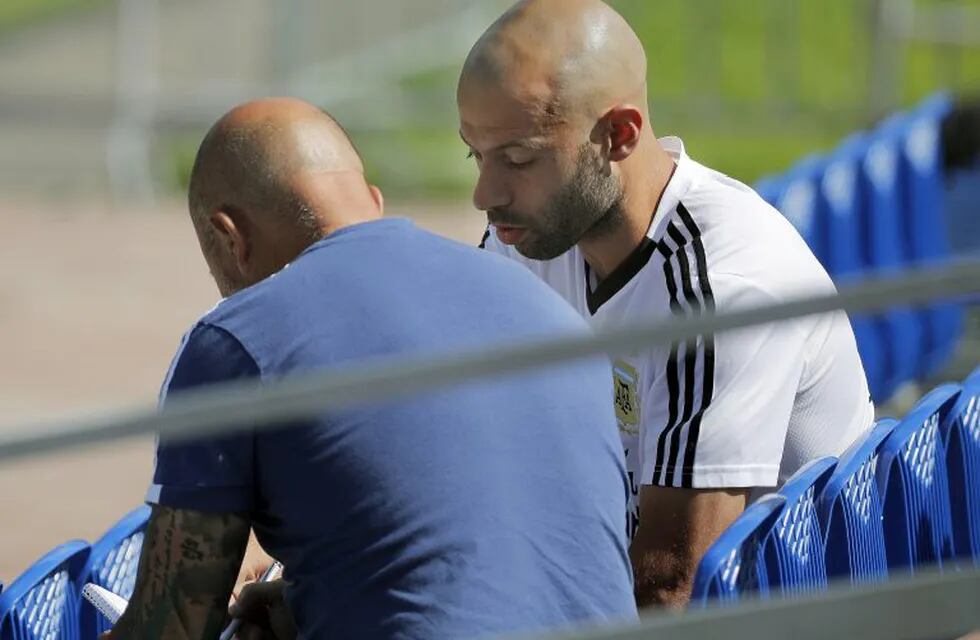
[{"xmin": 693, "ymin": 368, "xmax": 980, "ymax": 605}]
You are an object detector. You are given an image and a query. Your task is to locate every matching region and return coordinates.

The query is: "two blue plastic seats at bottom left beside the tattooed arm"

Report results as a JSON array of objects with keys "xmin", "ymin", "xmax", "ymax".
[{"xmin": 0, "ymin": 505, "xmax": 150, "ymax": 640}]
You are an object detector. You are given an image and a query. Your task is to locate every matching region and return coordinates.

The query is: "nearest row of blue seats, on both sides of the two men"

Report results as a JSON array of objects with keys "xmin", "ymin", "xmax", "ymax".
[{"xmin": 0, "ymin": 356, "xmax": 980, "ymax": 640}]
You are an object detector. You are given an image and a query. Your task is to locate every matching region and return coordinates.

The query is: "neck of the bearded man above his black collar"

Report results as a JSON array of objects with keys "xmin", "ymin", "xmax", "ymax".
[{"xmin": 578, "ymin": 139, "xmax": 675, "ymax": 281}]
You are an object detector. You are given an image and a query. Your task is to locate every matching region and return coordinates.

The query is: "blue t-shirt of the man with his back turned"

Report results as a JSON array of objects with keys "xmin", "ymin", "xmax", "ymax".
[{"xmin": 148, "ymin": 219, "xmax": 636, "ymax": 638}]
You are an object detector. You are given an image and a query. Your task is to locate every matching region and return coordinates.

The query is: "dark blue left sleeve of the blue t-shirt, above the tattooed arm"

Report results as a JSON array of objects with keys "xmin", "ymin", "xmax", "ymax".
[{"xmin": 147, "ymin": 324, "xmax": 259, "ymax": 512}]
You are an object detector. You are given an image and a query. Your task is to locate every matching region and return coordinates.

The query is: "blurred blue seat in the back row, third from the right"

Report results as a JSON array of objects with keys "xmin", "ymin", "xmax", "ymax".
[{"xmin": 818, "ymin": 135, "xmax": 899, "ymax": 402}]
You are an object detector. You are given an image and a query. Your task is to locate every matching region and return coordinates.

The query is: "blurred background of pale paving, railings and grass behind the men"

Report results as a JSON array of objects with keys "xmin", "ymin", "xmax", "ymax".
[{"xmin": 0, "ymin": 0, "xmax": 980, "ymax": 582}]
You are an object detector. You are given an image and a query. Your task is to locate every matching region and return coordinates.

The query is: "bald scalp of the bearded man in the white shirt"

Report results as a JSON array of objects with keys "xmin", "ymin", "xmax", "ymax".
[{"xmin": 459, "ymin": 0, "xmax": 647, "ymax": 121}]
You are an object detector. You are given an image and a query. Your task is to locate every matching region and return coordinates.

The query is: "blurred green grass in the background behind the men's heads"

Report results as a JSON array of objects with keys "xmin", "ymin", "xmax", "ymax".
[{"xmin": 168, "ymin": 0, "xmax": 980, "ymax": 199}]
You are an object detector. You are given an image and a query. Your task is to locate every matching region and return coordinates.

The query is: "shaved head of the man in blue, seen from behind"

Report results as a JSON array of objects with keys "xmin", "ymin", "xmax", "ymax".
[{"xmin": 188, "ymin": 98, "xmax": 380, "ymax": 295}]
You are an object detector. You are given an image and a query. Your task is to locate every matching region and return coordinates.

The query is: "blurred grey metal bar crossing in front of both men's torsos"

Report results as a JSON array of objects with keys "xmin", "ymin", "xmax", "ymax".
[{"xmin": 0, "ymin": 262, "xmax": 980, "ymax": 461}]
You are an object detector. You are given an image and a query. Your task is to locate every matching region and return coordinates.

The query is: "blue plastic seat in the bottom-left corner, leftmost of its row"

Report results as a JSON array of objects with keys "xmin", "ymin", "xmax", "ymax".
[{"xmin": 0, "ymin": 540, "xmax": 89, "ymax": 640}]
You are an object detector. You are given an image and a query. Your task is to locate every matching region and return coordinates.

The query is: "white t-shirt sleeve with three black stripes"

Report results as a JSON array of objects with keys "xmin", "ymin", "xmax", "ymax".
[{"xmin": 643, "ymin": 275, "xmax": 806, "ymax": 489}]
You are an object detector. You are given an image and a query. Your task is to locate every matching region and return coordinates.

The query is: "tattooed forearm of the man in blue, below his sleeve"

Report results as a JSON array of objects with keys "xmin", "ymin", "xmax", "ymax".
[{"xmin": 103, "ymin": 506, "xmax": 249, "ymax": 640}]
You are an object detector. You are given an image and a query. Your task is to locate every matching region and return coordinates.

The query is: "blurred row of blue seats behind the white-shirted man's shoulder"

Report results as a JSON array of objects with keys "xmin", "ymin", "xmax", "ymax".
[{"xmin": 756, "ymin": 95, "xmax": 963, "ymax": 402}]
